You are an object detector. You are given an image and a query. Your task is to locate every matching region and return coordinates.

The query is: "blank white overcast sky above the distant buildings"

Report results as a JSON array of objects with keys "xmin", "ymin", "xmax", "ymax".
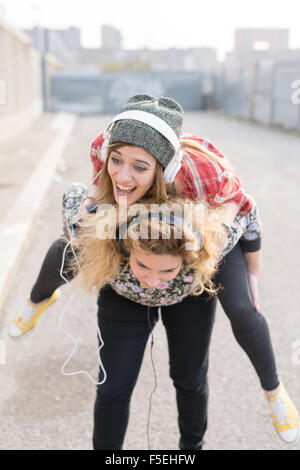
[{"xmin": 0, "ymin": 0, "xmax": 300, "ymax": 59}]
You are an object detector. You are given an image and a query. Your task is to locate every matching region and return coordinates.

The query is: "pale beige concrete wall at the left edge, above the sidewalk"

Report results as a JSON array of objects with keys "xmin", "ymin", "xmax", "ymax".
[{"xmin": 0, "ymin": 20, "xmax": 43, "ymax": 142}]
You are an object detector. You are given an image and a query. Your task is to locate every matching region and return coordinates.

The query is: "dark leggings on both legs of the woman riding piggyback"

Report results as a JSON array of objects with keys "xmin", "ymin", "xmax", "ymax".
[{"xmin": 31, "ymin": 239, "xmax": 279, "ymax": 390}]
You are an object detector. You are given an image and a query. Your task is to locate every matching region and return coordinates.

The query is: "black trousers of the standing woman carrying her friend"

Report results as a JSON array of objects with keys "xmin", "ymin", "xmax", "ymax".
[{"xmin": 93, "ymin": 286, "xmax": 216, "ymax": 450}]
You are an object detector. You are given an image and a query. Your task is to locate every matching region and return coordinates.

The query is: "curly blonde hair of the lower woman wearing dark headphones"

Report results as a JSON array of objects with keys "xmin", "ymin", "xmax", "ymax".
[{"xmin": 72, "ymin": 196, "xmax": 226, "ymax": 295}]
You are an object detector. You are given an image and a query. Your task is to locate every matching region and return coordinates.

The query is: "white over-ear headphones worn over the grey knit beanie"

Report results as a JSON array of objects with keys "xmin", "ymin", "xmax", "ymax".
[{"xmin": 101, "ymin": 111, "xmax": 183, "ymax": 183}]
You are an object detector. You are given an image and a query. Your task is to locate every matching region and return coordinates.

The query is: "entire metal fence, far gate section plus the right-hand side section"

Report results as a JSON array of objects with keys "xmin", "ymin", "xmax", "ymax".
[{"xmin": 48, "ymin": 61, "xmax": 300, "ymax": 129}]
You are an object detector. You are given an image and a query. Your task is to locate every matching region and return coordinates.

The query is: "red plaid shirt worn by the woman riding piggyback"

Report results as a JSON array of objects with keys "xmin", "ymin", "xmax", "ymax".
[{"xmin": 90, "ymin": 129, "xmax": 252, "ymax": 217}]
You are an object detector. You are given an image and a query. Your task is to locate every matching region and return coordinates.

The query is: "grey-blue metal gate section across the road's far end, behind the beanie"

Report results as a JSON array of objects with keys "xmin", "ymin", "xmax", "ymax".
[{"xmin": 49, "ymin": 71, "xmax": 203, "ymax": 114}]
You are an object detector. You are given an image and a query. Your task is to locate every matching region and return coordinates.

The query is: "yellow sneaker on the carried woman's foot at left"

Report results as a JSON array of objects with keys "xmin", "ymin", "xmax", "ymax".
[{"xmin": 8, "ymin": 289, "xmax": 59, "ymax": 339}]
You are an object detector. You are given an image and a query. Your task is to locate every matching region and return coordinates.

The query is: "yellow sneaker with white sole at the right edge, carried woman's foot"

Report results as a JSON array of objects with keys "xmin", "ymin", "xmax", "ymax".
[{"xmin": 269, "ymin": 384, "xmax": 300, "ymax": 444}]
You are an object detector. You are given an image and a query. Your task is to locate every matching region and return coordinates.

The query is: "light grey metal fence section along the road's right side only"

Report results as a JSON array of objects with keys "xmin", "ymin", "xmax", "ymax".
[{"xmin": 218, "ymin": 62, "xmax": 300, "ymax": 129}]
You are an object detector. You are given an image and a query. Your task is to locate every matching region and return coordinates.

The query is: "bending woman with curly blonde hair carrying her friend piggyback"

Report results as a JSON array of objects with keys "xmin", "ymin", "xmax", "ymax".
[{"xmin": 72, "ymin": 197, "xmax": 226, "ymax": 450}]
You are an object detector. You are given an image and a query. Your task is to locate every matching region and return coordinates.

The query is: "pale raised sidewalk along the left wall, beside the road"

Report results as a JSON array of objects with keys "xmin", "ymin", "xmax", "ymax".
[{"xmin": 0, "ymin": 113, "xmax": 77, "ymax": 312}]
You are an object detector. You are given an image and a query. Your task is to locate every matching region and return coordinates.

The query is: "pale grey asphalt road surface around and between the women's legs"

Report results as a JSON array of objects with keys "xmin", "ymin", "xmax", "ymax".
[{"xmin": 0, "ymin": 113, "xmax": 300, "ymax": 450}]
